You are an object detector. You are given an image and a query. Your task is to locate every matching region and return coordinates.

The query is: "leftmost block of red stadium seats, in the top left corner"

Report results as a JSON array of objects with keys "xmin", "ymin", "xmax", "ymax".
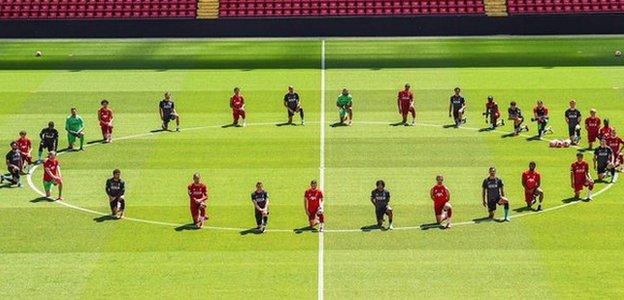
[{"xmin": 0, "ymin": 0, "xmax": 197, "ymax": 19}]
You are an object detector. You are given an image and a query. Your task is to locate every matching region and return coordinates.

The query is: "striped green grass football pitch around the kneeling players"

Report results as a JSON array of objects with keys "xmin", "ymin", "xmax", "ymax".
[{"xmin": 0, "ymin": 36, "xmax": 624, "ymax": 299}]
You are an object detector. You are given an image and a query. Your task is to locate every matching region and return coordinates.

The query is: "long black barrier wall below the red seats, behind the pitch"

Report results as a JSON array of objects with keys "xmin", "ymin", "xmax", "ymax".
[{"xmin": 0, "ymin": 14, "xmax": 624, "ymax": 38}]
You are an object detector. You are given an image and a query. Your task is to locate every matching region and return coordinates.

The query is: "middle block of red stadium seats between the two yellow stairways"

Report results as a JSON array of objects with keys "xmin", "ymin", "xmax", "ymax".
[{"xmin": 219, "ymin": 0, "xmax": 485, "ymax": 18}]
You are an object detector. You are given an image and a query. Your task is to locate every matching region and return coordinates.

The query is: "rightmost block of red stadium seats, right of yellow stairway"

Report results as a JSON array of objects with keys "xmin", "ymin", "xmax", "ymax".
[{"xmin": 507, "ymin": 0, "xmax": 624, "ymax": 15}]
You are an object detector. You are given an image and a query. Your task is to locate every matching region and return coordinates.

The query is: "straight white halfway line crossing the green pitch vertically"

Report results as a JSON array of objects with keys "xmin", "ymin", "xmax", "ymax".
[{"xmin": 317, "ymin": 40, "xmax": 326, "ymax": 300}]
